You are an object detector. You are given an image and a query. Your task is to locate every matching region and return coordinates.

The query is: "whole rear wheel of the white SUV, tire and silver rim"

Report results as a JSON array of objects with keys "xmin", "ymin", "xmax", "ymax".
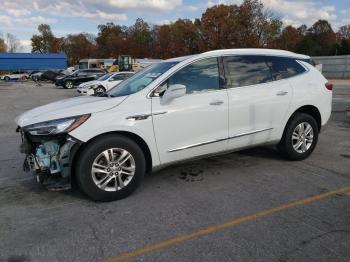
[{"xmin": 278, "ymin": 113, "xmax": 319, "ymax": 160}]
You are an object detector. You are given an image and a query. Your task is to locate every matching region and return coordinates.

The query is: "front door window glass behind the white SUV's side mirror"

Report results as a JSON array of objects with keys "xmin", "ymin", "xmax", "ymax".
[{"xmin": 167, "ymin": 57, "xmax": 220, "ymax": 94}]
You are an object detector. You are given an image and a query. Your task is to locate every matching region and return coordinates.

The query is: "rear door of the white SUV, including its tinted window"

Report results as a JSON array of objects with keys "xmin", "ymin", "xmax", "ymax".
[{"xmin": 223, "ymin": 55, "xmax": 292, "ymax": 149}]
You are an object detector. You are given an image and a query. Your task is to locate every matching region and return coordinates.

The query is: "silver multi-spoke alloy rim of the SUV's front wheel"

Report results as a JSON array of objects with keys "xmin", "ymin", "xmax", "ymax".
[{"xmin": 91, "ymin": 148, "xmax": 135, "ymax": 192}]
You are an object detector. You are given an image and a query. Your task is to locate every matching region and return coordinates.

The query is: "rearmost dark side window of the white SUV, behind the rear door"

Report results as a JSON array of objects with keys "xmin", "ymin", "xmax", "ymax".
[{"xmin": 266, "ymin": 56, "xmax": 305, "ymax": 80}]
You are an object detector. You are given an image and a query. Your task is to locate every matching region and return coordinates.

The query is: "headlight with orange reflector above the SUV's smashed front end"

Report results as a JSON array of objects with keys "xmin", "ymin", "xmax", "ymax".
[{"xmin": 23, "ymin": 114, "xmax": 90, "ymax": 136}]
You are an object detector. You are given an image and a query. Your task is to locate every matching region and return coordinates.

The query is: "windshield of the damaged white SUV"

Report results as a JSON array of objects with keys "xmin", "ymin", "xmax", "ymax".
[{"xmin": 107, "ymin": 62, "xmax": 178, "ymax": 97}]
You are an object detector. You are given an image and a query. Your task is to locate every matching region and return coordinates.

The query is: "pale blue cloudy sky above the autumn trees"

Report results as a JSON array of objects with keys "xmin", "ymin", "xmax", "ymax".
[{"xmin": 0, "ymin": 0, "xmax": 350, "ymax": 52}]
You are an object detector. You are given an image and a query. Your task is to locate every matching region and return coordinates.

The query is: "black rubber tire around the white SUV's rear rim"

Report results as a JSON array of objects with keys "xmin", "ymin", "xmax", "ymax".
[{"xmin": 277, "ymin": 113, "xmax": 319, "ymax": 160}]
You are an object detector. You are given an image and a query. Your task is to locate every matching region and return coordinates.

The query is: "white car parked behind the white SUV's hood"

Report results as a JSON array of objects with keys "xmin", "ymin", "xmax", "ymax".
[{"xmin": 77, "ymin": 72, "xmax": 134, "ymax": 95}]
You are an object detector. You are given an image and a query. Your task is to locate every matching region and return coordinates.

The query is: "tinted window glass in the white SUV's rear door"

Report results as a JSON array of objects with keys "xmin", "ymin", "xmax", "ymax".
[{"xmin": 223, "ymin": 55, "xmax": 272, "ymax": 88}]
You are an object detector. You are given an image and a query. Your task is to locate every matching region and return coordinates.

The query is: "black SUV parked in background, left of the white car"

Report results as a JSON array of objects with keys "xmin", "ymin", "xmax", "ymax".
[{"xmin": 55, "ymin": 68, "xmax": 106, "ymax": 89}]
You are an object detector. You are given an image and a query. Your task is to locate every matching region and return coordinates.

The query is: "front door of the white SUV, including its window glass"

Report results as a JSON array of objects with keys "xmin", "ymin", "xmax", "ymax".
[{"xmin": 152, "ymin": 57, "xmax": 228, "ymax": 164}]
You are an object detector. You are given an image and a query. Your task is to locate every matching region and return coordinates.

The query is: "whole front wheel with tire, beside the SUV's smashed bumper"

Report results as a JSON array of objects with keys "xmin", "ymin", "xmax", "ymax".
[{"xmin": 76, "ymin": 135, "xmax": 146, "ymax": 201}]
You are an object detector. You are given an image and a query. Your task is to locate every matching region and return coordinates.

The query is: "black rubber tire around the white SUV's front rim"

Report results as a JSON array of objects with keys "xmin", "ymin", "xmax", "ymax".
[{"xmin": 75, "ymin": 135, "xmax": 146, "ymax": 201}]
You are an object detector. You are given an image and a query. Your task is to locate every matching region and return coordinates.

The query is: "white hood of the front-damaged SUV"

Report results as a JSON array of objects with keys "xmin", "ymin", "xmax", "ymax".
[{"xmin": 15, "ymin": 96, "xmax": 126, "ymax": 127}]
